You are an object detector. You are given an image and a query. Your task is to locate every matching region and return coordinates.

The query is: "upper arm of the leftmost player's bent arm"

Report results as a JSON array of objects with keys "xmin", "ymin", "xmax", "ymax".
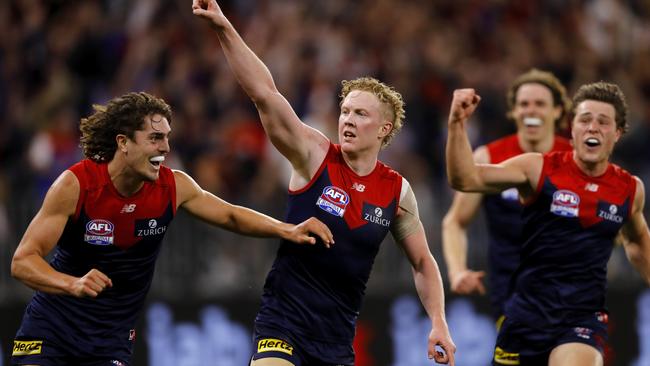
[{"xmin": 14, "ymin": 171, "xmax": 80, "ymax": 258}]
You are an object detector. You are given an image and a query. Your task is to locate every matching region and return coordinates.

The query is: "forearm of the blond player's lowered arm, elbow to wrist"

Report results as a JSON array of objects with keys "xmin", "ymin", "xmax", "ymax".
[{"xmin": 413, "ymin": 256, "xmax": 445, "ymax": 326}]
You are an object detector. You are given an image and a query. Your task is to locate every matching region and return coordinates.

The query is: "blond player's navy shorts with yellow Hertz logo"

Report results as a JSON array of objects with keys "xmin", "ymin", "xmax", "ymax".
[{"xmin": 253, "ymin": 324, "xmax": 354, "ymax": 366}]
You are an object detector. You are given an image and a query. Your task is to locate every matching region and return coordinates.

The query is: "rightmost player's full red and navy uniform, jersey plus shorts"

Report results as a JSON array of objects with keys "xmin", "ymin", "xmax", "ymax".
[{"xmin": 494, "ymin": 152, "xmax": 636, "ymax": 365}]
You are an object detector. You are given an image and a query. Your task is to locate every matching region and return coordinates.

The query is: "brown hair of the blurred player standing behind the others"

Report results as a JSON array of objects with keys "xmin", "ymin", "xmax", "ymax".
[{"xmin": 506, "ymin": 69, "xmax": 571, "ymax": 130}]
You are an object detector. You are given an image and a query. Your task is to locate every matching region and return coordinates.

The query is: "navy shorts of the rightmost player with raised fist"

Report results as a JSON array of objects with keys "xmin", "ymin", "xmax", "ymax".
[{"xmin": 492, "ymin": 312, "xmax": 608, "ymax": 366}]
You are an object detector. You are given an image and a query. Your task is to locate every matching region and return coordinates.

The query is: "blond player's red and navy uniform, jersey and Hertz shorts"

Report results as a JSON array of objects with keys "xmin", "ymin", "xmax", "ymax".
[{"xmin": 253, "ymin": 144, "xmax": 403, "ymax": 366}]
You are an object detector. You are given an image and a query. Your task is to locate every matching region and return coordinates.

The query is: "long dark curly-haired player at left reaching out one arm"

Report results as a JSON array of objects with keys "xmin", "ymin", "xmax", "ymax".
[{"xmin": 11, "ymin": 93, "xmax": 332, "ymax": 366}]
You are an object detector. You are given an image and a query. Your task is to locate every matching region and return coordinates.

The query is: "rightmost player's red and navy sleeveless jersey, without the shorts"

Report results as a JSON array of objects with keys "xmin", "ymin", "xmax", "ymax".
[{"xmin": 506, "ymin": 152, "xmax": 636, "ymax": 329}]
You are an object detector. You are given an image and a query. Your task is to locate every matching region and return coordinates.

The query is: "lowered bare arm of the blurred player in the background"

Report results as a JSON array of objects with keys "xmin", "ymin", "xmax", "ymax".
[{"xmin": 442, "ymin": 146, "xmax": 490, "ymax": 295}]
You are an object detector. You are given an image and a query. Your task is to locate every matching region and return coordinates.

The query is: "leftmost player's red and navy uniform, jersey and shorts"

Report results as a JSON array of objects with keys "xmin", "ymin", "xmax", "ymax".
[{"xmin": 12, "ymin": 160, "xmax": 176, "ymax": 366}]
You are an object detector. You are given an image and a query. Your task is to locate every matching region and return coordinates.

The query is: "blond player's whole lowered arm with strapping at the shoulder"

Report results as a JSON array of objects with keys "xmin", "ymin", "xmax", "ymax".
[{"xmin": 391, "ymin": 179, "xmax": 456, "ymax": 366}]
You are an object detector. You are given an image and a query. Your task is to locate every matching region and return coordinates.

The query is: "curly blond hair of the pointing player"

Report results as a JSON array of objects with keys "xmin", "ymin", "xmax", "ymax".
[{"xmin": 340, "ymin": 77, "xmax": 405, "ymax": 149}]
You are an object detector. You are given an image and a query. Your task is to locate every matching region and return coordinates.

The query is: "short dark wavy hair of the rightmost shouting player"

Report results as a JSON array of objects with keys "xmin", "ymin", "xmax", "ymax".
[{"xmin": 572, "ymin": 81, "xmax": 630, "ymax": 133}]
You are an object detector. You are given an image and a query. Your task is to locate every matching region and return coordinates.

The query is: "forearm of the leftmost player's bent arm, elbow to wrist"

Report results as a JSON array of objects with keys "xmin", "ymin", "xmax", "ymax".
[{"xmin": 11, "ymin": 254, "xmax": 76, "ymax": 294}]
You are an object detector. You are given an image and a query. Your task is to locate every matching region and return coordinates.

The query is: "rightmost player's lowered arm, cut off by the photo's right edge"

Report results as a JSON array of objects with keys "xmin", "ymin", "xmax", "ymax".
[{"xmin": 621, "ymin": 177, "xmax": 650, "ymax": 284}]
